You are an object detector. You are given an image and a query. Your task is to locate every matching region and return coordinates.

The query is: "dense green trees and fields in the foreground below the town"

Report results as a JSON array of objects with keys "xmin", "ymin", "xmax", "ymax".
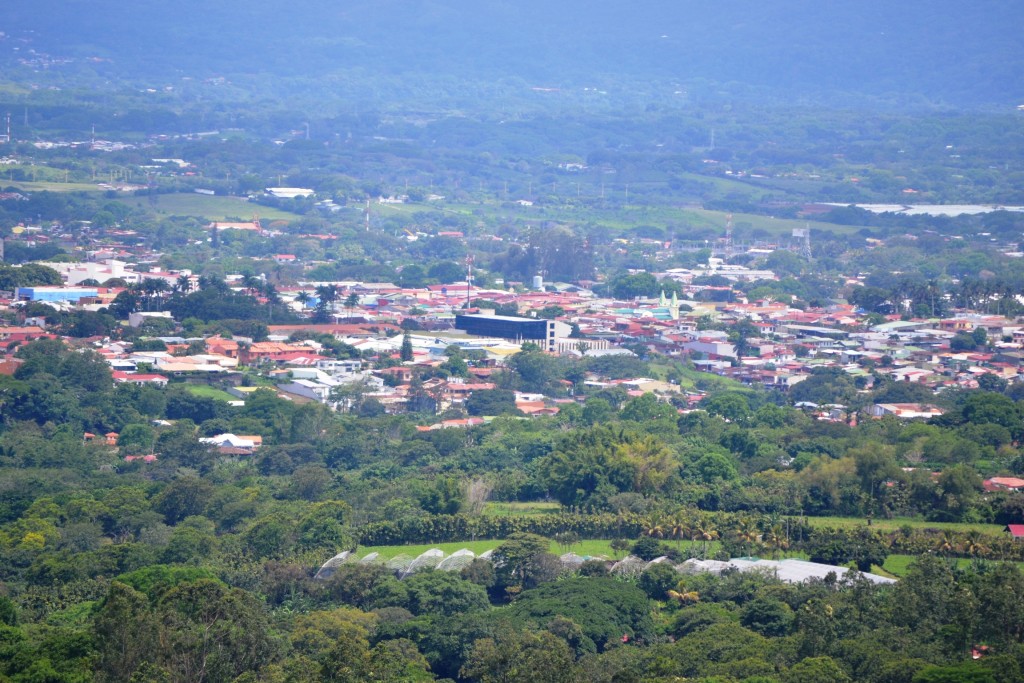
[{"xmin": 0, "ymin": 340, "xmax": 1024, "ymax": 681}]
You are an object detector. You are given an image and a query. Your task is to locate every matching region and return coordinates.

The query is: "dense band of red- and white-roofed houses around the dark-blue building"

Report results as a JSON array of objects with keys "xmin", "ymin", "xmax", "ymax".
[{"xmin": 0, "ymin": 229, "xmax": 1024, "ymax": 447}]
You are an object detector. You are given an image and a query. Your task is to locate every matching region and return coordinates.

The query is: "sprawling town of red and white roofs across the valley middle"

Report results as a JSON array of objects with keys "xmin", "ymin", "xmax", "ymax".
[{"xmin": 0, "ymin": 214, "xmax": 1024, "ymax": 440}]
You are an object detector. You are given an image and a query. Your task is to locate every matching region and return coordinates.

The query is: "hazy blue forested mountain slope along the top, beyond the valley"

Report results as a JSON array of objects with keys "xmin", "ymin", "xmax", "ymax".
[{"xmin": 0, "ymin": 0, "xmax": 1024, "ymax": 105}]
